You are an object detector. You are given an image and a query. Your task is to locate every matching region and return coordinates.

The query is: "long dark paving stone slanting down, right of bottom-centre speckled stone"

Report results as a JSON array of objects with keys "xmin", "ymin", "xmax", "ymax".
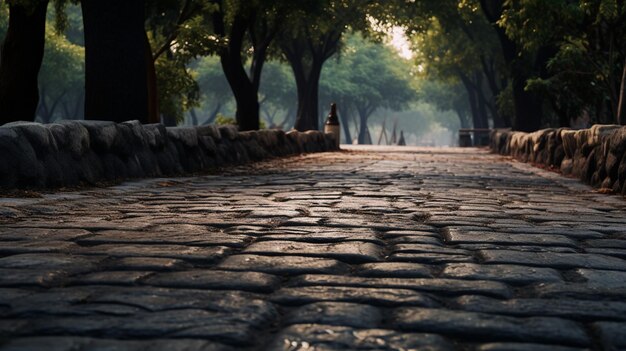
[{"xmin": 392, "ymin": 307, "xmax": 591, "ymax": 346}]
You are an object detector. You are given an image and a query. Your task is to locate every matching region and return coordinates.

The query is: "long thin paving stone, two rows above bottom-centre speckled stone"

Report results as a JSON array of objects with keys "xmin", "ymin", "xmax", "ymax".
[{"xmin": 270, "ymin": 286, "xmax": 438, "ymax": 307}]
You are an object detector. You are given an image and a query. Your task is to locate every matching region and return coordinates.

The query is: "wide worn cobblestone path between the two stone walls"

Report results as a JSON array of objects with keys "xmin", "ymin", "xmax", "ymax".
[{"xmin": 0, "ymin": 148, "xmax": 626, "ymax": 351}]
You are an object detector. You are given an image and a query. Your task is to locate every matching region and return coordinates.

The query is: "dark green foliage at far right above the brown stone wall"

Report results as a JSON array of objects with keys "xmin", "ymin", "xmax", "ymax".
[{"xmin": 498, "ymin": 0, "xmax": 626, "ymax": 122}]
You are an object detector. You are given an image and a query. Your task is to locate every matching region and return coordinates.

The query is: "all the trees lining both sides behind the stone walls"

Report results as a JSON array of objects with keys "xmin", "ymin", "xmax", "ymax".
[{"xmin": 0, "ymin": 0, "xmax": 626, "ymax": 133}]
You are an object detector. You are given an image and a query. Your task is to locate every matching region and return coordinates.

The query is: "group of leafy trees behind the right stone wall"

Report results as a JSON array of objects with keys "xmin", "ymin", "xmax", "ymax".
[{"xmin": 391, "ymin": 0, "xmax": 626, "ymax": 131}]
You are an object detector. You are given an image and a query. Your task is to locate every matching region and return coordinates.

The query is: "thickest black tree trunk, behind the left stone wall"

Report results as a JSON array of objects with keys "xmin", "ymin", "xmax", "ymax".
[{"xmin": 81, "ymin": 0, "xmax": 149, "ymax": 123}]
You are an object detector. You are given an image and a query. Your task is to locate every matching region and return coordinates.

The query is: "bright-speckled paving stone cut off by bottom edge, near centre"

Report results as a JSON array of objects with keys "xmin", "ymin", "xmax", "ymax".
[{"xmin": 268, "ymin": 324, "xmax": 454, "ymax": 351}]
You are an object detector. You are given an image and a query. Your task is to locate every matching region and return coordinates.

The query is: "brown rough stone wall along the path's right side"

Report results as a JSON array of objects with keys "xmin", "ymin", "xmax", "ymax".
[{"xmin": 491, "ymin": 125, "xmax": 626, "ymax": 195}]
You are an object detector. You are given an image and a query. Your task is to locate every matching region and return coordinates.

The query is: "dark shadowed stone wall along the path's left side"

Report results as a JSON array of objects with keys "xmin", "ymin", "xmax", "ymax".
[{"xmin": 0, "ymin": 121, "xmax": 336, "ymax": 188}]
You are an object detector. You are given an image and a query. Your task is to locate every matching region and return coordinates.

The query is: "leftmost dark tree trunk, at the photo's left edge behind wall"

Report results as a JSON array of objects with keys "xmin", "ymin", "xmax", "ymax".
[{"xmin": 0, "ymin": 0, "xmax": 48, "ymax": 124}]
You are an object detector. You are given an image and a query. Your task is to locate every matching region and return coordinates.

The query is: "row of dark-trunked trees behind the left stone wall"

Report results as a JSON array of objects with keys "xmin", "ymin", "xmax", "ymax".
[{"xmin": 0, "ymin": 0, "xmax": 380, "ymax": 130}]
